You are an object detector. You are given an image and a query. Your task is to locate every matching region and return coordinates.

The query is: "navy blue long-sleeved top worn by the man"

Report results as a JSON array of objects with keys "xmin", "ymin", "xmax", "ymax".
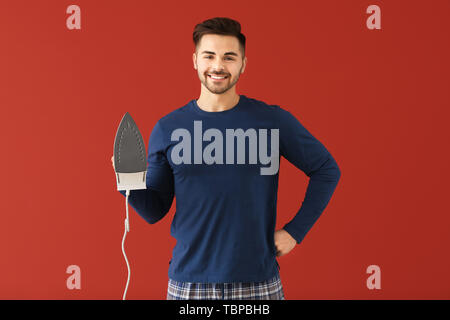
[{"xmin": 119, "ymin": 95, "xmax": 341, "ymax": 283}]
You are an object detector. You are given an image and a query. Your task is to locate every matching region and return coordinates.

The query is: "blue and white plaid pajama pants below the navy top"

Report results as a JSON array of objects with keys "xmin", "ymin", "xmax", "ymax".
[{"xmin": 167, "ymin": 274, "xmax": 285, "ymax": 300}]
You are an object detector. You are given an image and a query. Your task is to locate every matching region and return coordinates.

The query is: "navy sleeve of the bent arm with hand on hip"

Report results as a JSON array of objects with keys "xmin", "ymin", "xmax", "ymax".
[{"xmin": 279, "ymin": 108, "xmax": 341, "ymax": 244}]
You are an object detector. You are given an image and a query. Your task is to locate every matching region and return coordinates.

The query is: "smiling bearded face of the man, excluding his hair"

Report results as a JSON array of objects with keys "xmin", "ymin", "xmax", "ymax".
[{"xmin": 193, "ymin": 34, "xmax": 247, "ymax": 94}]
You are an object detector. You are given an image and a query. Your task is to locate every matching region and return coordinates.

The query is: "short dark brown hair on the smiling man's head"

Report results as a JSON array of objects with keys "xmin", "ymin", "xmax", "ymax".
[{"xmin": 192, "ymin": 17, "xmax": 245, "ymax": 59}]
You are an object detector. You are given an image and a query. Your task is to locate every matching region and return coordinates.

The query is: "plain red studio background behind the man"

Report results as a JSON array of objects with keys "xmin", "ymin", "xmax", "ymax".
[{"xmin": 0, "ymin": 0, "xmax": 450, "ymax": 299}]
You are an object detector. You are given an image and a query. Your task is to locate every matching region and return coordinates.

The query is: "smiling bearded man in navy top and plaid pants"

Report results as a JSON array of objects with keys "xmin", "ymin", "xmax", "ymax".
[{"xmin": 111, "ymin": 18, "xmax": 340, "ymax": 300}]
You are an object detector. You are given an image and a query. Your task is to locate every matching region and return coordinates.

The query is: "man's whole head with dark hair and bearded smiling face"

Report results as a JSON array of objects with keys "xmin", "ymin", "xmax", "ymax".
[{"xmin": 192, "ymin": 17, "xmax": 247, "ymax": 94}]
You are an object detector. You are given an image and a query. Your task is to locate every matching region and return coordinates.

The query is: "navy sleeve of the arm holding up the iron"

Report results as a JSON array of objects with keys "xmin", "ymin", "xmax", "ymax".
[{"xmin": 119, "ymin": 121, "xmax": 175, "ymax": 224}]
